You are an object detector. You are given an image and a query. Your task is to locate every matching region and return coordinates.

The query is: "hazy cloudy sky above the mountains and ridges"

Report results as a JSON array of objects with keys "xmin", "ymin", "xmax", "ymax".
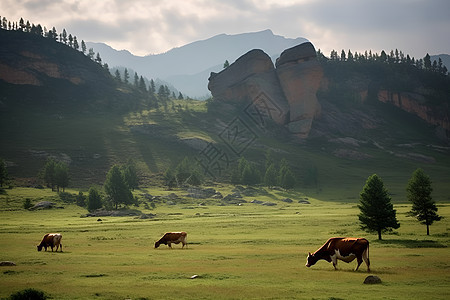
[{"xmin": 0, "ymin": 0, "xmax": 450, "ymax": 58}]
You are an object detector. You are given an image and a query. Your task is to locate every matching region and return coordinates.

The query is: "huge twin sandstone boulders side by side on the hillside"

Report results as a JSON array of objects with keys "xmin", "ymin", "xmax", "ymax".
[{"xmin": 208, "ymin": 42, "xmax": 323, "ymax": 138}]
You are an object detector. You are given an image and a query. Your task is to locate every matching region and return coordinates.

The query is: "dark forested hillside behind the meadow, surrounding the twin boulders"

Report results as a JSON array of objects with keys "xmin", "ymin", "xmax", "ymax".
[{"xmin": 0, "ymin": 16, "xmax": 450, "ymax": 200}]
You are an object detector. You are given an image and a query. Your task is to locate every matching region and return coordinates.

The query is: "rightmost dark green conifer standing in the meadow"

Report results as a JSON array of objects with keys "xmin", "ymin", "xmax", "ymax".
[{"xmin": 406, "ymin": 168, "xmax": 442, "ymax": 235}]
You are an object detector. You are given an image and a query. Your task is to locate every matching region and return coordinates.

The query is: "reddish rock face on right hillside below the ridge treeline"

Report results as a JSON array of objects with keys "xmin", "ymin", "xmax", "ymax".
[{"xmin": 378, "ymin": 90, "xmax": 450, "ymax": 132}]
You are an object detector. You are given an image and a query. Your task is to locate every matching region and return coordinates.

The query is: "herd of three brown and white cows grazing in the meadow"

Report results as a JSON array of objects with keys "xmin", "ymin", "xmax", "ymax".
[{"xmin": 37, "ymin": 231, "xmax": 370, "ymax": 272}]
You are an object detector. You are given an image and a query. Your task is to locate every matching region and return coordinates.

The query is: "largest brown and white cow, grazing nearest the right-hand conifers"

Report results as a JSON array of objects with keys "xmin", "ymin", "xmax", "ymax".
[{"xmin": 306, "ymin": 237, "xmax": 370, "ymax": 272}]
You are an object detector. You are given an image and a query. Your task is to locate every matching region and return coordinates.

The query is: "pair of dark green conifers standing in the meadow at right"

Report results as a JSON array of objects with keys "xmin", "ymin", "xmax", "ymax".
[{"xmin": 358, "ymin": 168, "xmax": 441, "ymax": 240}]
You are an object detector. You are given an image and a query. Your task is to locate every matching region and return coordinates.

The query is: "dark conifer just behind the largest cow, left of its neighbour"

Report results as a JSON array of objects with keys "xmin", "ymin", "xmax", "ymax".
[{"xmin": 358, "ymin": 174, "xmax": 400, "ymax": 240}]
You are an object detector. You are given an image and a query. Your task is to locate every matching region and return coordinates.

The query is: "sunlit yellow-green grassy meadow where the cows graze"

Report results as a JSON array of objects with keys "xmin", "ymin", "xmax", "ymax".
[{"xmin": 0, "ymin": 185, "xmax": 450, "ymax": 299}]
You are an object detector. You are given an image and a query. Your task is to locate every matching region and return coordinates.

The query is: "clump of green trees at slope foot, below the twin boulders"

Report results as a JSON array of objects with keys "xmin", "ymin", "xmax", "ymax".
[{"xmin": 231, "ymin": 150, "xmax": 296, "ymax": 189}]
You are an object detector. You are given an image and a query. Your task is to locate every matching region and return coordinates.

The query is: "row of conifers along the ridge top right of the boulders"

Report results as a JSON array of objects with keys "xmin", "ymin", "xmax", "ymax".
[{"xmin": 317, "ymin": 49, "xmax": 448, "ymax": 75}]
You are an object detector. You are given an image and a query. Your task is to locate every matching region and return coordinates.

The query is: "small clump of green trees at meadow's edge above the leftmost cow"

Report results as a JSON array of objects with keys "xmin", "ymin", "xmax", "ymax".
[{"xmin": 40, "ymin": 158, "xmax": 70, "ymax": 192}]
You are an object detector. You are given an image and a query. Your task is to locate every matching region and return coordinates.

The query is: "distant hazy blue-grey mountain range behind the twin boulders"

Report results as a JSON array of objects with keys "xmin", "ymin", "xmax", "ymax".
[{"xmin": 86, "ymin": 30, "xmax": 307, "ymax": 98}]
